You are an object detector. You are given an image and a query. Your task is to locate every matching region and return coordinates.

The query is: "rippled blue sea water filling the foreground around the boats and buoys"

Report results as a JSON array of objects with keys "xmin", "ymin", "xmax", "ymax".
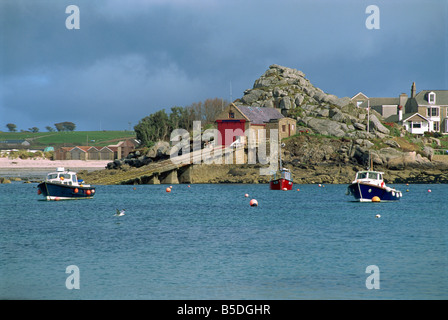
[{"xmin": 0, "ymin": 183, "xmax": 448, "ymax": 299}]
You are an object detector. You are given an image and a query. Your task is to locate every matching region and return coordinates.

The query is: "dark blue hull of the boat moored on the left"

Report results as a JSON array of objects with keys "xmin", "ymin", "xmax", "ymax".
[{"xmin": 37, "ymin": 182, "xmax": 95, "ymax": 201}]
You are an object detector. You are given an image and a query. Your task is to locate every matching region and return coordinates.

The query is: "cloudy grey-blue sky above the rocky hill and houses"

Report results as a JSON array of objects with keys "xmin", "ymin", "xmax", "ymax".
[{"xmin": 0, "ymin": 0, "xmax": 448, "ymax": 131}]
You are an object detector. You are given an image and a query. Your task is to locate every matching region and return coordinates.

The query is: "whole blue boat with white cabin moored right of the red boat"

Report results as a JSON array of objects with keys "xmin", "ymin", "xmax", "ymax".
[{"xmin": 346, "ymin": 170, "xmax": 403, "ymax": 202}]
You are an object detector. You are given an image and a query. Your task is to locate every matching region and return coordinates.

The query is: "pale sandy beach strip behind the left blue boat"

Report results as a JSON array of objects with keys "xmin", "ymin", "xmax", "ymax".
[{"xmin": 0, "ymin": 157, "xmax": 110, "ymax": 178}]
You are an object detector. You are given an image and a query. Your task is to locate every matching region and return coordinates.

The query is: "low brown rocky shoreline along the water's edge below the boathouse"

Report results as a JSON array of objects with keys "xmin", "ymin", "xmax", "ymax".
[{"xmin": 81, "ymin": 134, "xmax": 448, "ymax": 184}]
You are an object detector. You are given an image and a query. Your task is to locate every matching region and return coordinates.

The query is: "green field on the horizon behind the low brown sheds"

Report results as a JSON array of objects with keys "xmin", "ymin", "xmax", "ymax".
[{"xmin": 0, "ymin": 131, "xmax": 135, "ymax": 149}]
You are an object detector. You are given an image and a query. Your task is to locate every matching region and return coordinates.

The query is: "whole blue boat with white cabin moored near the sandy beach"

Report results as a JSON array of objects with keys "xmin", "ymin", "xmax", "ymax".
[{"xmin": 37, "ymin": 167, "xmax": 95, "ymax": 201}]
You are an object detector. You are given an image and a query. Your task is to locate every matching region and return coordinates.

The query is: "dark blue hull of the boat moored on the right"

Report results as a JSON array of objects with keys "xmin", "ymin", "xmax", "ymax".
[{"xmin": 348, "ymin": 182, "xmax": 403, "ymax": 202}]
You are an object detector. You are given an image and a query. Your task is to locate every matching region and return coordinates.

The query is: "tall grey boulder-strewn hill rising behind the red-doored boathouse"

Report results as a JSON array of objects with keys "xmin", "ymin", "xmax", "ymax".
[{"xmin": 235, "ymin": 64, "xmax": 396, "ymax": 138}]
